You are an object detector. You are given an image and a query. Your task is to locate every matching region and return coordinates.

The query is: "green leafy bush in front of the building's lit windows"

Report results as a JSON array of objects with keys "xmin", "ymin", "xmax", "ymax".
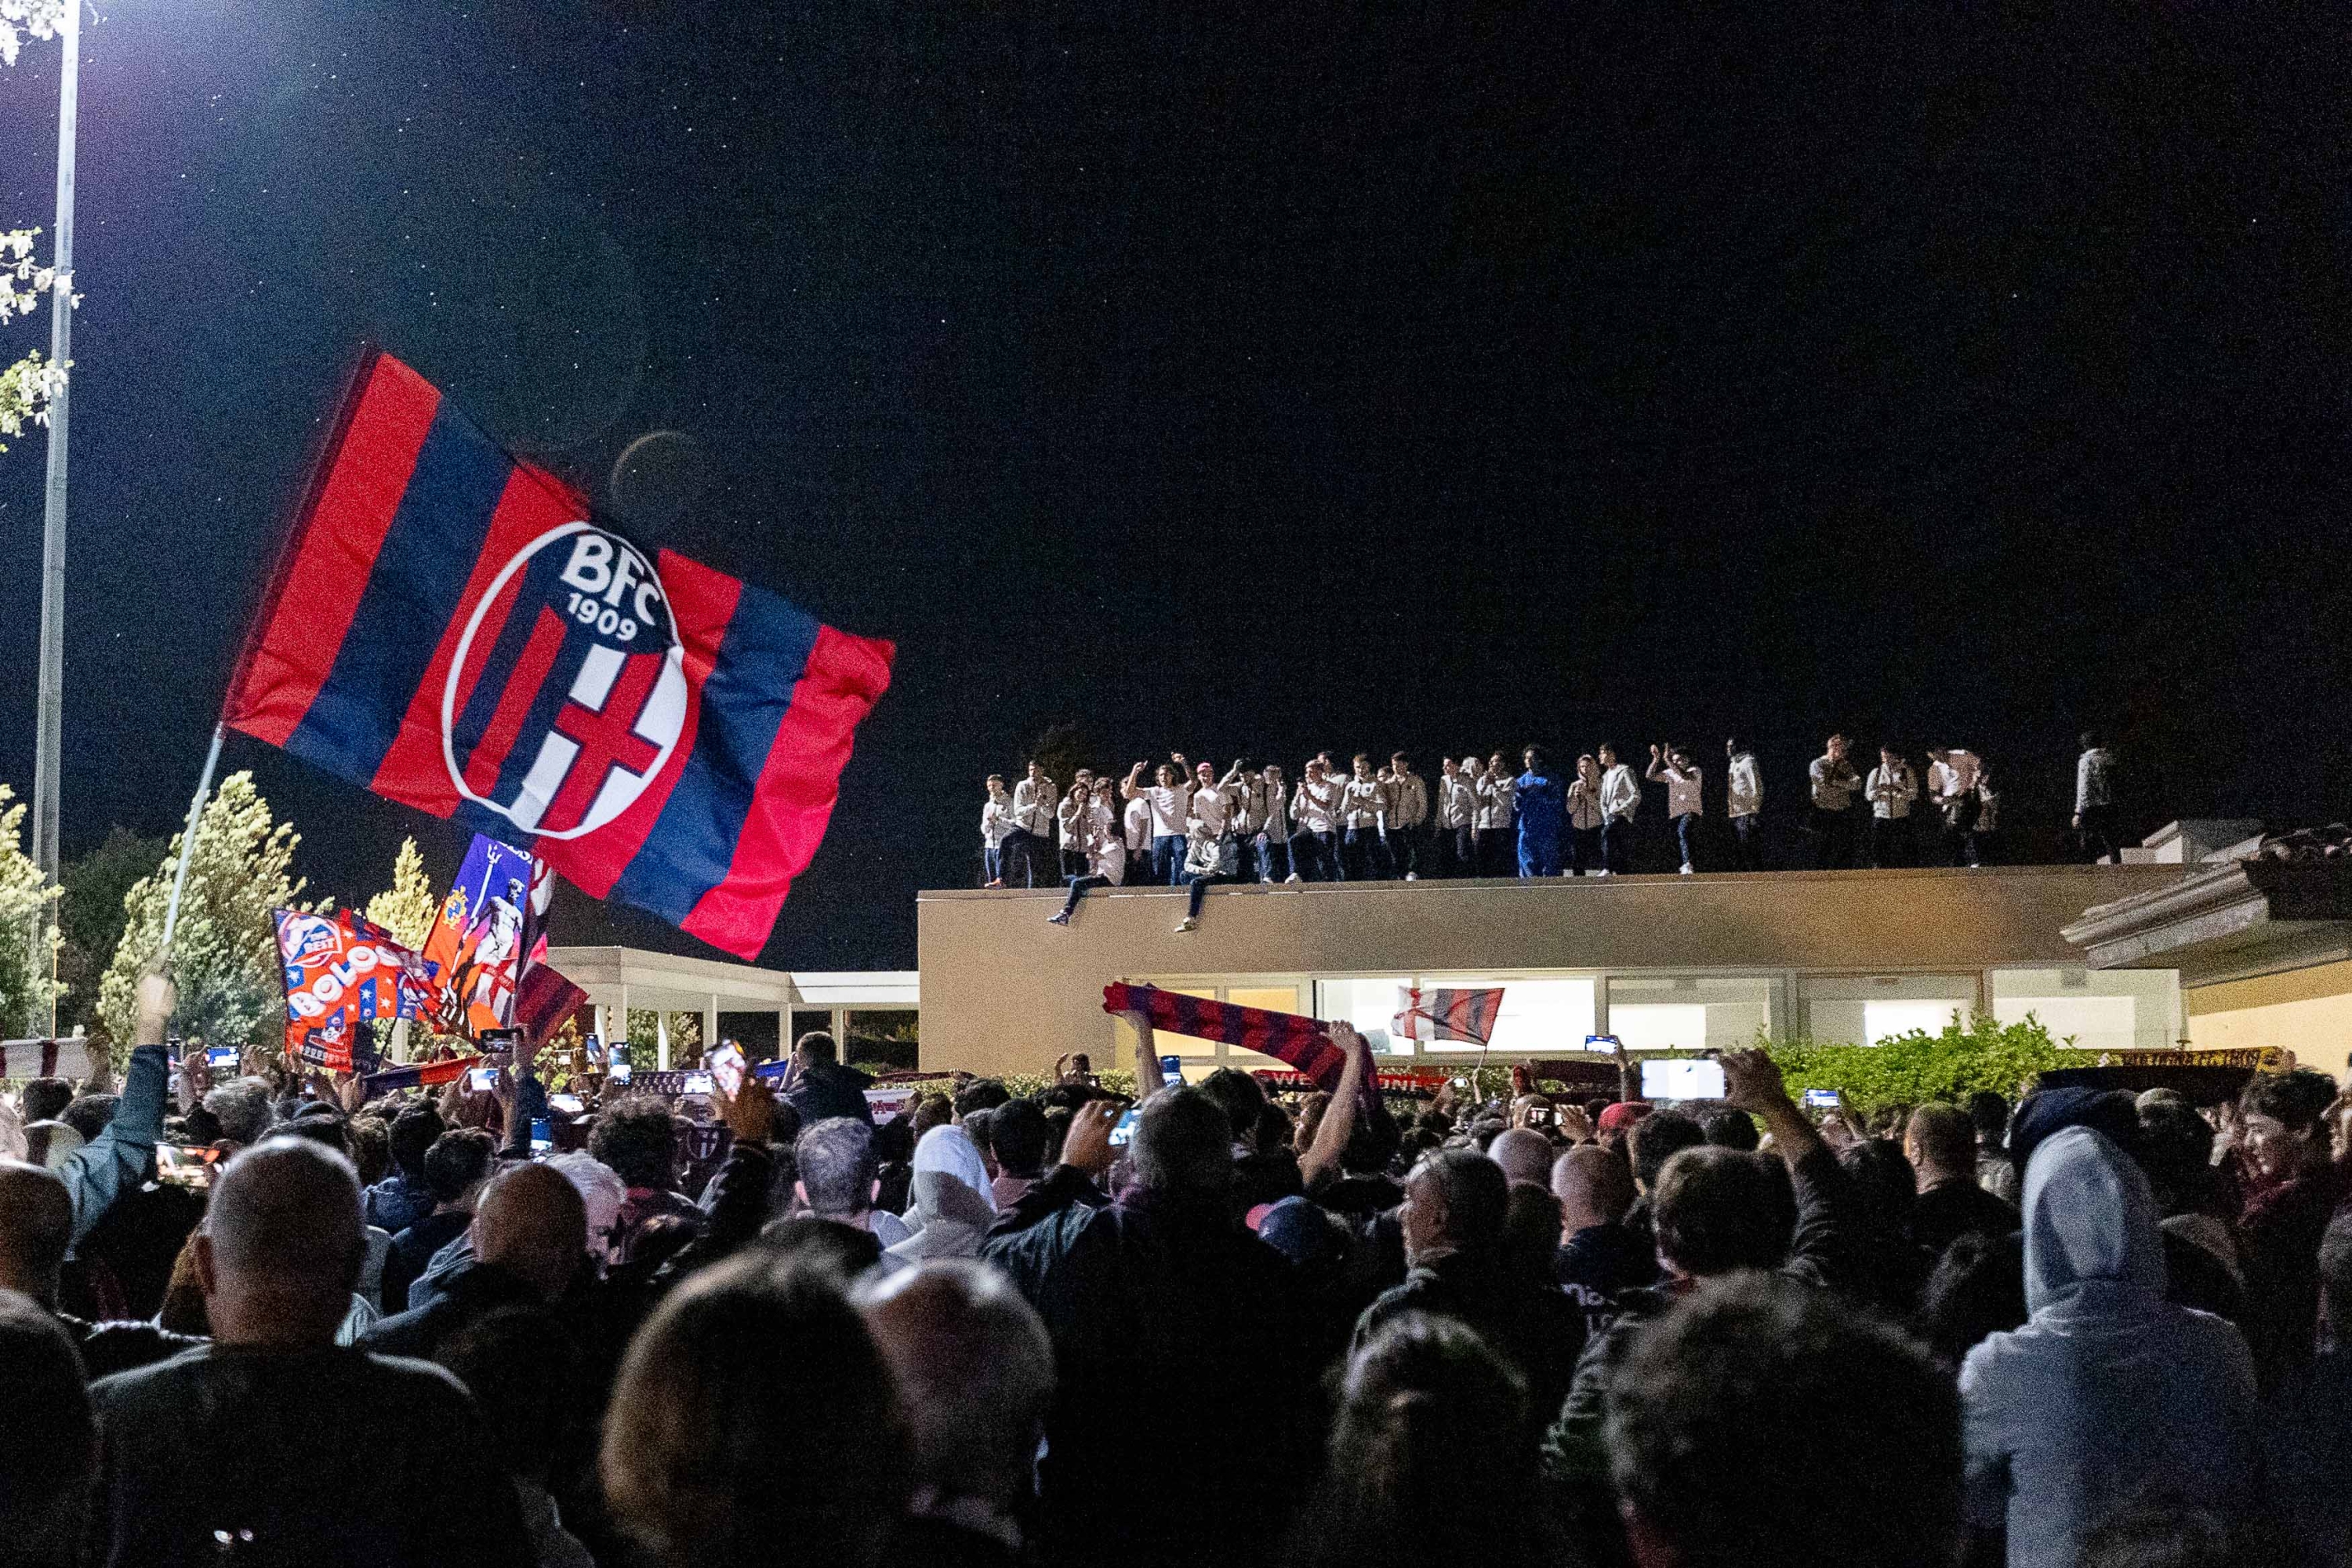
[{"xmin": 1757, "ymin": 1013, "xmax": 2098, "ymax": 1114}]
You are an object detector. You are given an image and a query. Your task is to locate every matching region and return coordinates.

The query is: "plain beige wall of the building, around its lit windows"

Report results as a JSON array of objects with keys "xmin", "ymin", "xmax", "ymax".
[{"xmin": 915, "ymin": 865, "xmax": 2183, "ymax": 1072}]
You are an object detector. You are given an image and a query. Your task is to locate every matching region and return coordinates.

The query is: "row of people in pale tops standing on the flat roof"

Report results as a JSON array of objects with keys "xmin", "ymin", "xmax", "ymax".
[{"xmin": 981, "ymin": 734, "xmax": 2122, "ymax": 916}]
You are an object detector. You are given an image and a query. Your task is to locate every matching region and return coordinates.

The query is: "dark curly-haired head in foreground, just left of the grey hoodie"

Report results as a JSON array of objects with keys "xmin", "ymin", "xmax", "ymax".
[{"xmin": 1606, "ymin": 1269, "xmax": 1962, "ymax": 1568}]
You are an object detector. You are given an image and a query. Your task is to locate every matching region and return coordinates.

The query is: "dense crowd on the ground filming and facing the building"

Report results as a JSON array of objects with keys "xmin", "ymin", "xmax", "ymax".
[{"xmin": 0, "ymin": 959, "xmax": 2352, "ymax": 1568}]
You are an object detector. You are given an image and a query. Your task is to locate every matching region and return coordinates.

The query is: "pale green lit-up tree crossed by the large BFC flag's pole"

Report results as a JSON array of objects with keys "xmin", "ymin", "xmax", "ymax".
[{"xmin": 99, "ymin": 774, "xmax": 313, "ymax": 1046}]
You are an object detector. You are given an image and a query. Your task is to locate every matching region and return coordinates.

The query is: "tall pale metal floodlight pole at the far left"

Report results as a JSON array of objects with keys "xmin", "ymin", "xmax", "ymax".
[{"xmin": 33, "ymin": 0, "xmax": 82, "ymax": 1011}]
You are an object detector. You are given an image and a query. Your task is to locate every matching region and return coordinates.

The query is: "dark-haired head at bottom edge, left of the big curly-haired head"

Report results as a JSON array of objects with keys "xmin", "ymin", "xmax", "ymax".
[{"xmin": 1291, "ymin": 1312, "xmax": 1536, "ymax": 1568}]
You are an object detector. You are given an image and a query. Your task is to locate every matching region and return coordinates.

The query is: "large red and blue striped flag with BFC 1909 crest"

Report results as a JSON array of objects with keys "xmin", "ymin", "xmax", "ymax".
[{"xmin": 221, "ymin": 353, "xmax": 894, "ymax": 959}]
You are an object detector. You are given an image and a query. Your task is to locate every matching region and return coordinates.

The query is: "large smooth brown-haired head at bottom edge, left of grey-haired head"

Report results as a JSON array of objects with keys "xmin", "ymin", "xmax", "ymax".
[{"xmin": 600, "ymin": 1250, "xmax": 913, "ymax": 1568}]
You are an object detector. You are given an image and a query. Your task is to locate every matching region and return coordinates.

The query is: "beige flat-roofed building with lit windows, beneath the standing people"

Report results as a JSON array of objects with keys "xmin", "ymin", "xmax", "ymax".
[{"xmin": 917, "ymin": 862, "xmax": 2199, "ymax": 1072}]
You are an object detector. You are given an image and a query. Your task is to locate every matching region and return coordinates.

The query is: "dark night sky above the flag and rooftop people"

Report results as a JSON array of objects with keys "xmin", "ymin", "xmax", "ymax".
[{"xmin": 0, "ymin": 0, "xmax": 2352, "ymax": 968}]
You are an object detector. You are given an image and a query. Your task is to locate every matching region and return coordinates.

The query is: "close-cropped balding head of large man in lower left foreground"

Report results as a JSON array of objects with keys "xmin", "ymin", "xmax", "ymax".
[{"xmin": 195, "ymin": 1138, "xmax": 362, "ymax": 1349}]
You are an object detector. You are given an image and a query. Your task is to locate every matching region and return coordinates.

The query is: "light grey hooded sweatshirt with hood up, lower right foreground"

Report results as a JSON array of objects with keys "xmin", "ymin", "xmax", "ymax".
[{"xmin": 1959, "ymin": 1126, "xmax": 2256, "ymax": 1568}]
